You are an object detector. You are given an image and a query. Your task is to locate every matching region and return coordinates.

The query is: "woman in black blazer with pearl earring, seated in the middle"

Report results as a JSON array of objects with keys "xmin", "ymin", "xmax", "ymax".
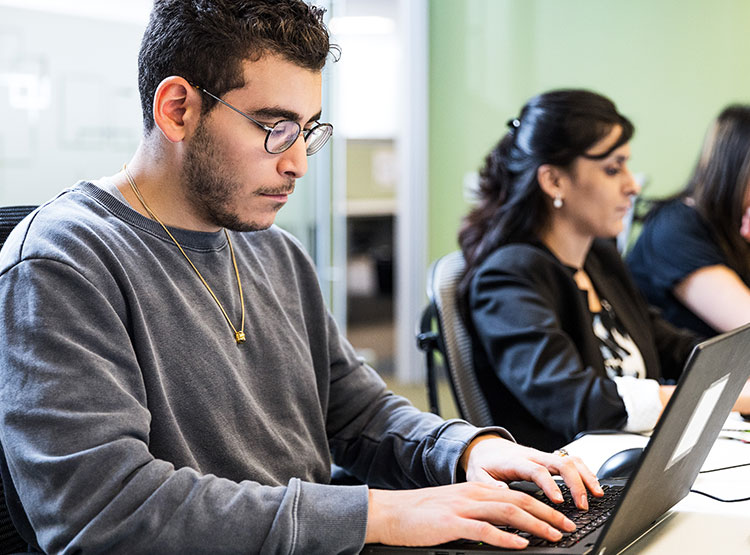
[{"xmin": 459, "ymin": 90, "xmax": 712, "ymax": 449}]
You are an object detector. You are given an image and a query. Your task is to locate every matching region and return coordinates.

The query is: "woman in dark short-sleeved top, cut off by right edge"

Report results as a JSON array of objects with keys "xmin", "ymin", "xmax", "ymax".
[{"xmin": 628, "ymin": 105, "xmax": 750, "ymax": 335}]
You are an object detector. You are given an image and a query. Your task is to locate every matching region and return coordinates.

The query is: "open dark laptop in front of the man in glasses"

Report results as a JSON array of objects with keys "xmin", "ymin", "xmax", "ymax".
[{"xmin": 362, "ymin": 324, "xmax": 750, "ymax": 555}]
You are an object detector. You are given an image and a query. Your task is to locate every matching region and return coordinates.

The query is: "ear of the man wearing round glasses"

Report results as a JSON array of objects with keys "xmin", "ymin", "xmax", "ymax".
[{"xmin": 154, "ymin": 75, "xmax": 202, "ymax": 143}]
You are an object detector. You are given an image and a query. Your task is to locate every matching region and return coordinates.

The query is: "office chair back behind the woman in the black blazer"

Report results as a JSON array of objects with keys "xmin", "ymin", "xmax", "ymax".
[{"xmin": 417, "ymin": 251, "xmax": 493, "ymax": 426}]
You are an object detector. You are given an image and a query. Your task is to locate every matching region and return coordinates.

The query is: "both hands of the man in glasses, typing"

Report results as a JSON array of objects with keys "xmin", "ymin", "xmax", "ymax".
[{"xmin": 365, "ymin": 434, "xmax": 604, "ymax": 549}]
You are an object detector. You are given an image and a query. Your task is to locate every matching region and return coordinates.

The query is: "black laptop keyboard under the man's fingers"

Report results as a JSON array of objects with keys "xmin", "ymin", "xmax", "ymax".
[{"xmin": 508, "ymin": 484, "xmax": 624, "ymax": 547}]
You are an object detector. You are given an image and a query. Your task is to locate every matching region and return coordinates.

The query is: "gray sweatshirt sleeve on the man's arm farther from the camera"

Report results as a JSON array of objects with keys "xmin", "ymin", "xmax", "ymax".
[{"xmin": 328, "ymin": 308, "xmax": 513, "ymax": 489}]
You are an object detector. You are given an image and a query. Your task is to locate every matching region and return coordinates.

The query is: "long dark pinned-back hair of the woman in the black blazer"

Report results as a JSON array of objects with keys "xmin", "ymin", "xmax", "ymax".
[{"xmin": 458, "ymin": 89, "xmax": 633, "ymax": 312}]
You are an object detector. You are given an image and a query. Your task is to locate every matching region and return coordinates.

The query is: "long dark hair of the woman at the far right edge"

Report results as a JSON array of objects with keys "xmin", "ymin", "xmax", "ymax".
[{"xmin": 672, "ymin": 104, "xmax": 750, "ymax": 283}]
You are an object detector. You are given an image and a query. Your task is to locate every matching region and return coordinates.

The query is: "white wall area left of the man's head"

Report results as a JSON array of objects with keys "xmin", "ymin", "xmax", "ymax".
[{"xmin": 0, "ymin": 2, "xmax": 145, "ymax": 205}]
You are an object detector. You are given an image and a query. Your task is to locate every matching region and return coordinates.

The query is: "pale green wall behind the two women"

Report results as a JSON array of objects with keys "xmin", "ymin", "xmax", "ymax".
[{"xmin": 429, "ymin": 0, "xmax": 750, "ymax": 260}]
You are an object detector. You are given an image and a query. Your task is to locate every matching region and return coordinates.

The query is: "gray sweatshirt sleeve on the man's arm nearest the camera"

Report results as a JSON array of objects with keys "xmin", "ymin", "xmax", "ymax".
[{"xmin": 0, "ymin": 259, "xmax": 367, "ymax": 553}]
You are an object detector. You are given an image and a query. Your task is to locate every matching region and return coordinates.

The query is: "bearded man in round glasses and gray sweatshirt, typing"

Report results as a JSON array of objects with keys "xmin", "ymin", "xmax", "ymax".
[{"xmin": 0, "ymin": 0, "xmax": 600, "ymax": 553}]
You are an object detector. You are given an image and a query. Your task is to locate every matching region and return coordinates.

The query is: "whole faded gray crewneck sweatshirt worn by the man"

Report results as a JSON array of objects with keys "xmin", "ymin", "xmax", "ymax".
[{"xmin": 0, "ymin": 182, "xmax": 506, "ymax": 554}]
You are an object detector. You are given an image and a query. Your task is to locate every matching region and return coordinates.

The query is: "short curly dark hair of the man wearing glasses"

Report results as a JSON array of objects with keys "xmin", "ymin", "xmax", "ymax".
[{"xmin": 138, "ymin": 0, "xmax": 339, "ymax": 133}]
